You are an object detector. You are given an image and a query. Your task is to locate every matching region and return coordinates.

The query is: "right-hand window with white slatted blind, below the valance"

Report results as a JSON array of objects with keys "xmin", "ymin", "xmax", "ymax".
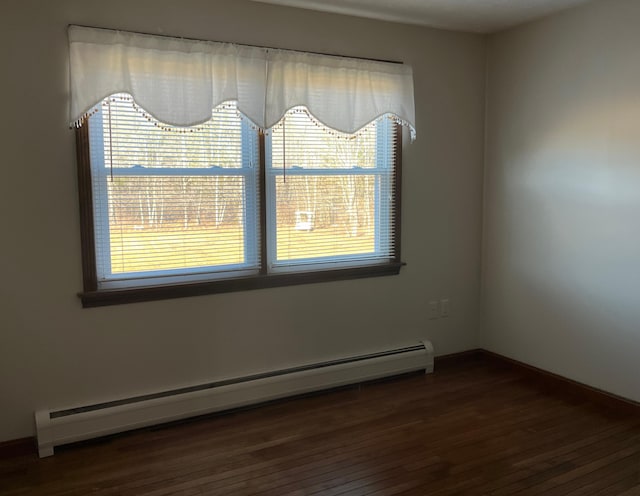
[{"xmin": 267, "ymin": 108, "xmax": 396, "ymax": 271}]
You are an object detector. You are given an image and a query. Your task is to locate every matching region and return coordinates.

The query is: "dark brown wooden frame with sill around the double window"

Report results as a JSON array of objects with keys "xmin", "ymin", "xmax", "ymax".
[{"xmin": 76, "ymin": 123, "xmax": 404, "ymax": 308}]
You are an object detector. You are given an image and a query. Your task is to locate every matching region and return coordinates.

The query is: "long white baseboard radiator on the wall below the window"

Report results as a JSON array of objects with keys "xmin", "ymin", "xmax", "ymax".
[{"xmin": 35, "ymin": 341, "xmax": 434, "ymax": 457}]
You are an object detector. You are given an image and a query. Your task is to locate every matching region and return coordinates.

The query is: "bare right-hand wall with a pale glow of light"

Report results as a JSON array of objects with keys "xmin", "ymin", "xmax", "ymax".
[{"xmin": 481, "ymin": 0, "xmax": 640, "ymax": 401}]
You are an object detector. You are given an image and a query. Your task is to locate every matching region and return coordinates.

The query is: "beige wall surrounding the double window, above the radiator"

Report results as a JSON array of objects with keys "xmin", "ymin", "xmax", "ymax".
[{"xmin": 0, "ymin": 0, "xmax": 485, "ymax": 441}]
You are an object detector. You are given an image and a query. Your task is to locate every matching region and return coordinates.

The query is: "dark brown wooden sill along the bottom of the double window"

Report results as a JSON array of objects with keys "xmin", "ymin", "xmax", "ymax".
[{"xmin": 79, "ymin": 262, "xmax": 404, "ymax": 308}]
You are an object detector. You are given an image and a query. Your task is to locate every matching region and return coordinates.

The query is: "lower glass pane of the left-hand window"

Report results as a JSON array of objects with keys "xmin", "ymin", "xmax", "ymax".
[{"xmin": 100, "ymin": 177, "xmax": 245, "ymax": 274}]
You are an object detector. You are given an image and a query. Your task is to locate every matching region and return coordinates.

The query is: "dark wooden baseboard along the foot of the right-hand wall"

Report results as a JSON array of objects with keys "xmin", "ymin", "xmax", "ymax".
[{"xmin": 482, "ymin": 349, "xmax": 640, "ymax": 415}]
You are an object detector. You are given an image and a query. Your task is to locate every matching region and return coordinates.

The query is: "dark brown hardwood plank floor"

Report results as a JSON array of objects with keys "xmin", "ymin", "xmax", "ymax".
[{"xmin": 0, "ymin": 357, "xmax": 640, "ymax": 496}]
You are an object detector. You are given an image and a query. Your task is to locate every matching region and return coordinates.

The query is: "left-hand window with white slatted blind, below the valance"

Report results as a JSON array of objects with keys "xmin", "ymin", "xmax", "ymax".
[{"xmin": 89, "ymin": 95, "xmax": 259, "ymax": 287}]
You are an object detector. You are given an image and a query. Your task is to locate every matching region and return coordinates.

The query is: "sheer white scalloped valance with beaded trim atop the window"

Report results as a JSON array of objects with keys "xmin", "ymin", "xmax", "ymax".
[{"xmin": 69, "ymin": 26, "xmax": 415, "ymax": 138}]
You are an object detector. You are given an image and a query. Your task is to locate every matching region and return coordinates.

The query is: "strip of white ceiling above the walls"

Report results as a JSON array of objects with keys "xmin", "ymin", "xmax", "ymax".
[{"xmin": 254, "ymin": 0, "xmax": 590, "ymax": 33}]
